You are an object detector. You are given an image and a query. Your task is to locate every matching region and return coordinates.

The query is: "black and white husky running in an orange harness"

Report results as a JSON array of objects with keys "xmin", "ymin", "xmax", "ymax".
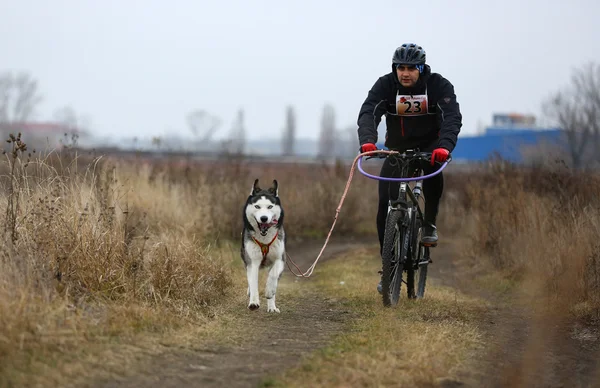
[{"xmin": 241, "ymin": 179, "xmax": 286, "ymax": 313}]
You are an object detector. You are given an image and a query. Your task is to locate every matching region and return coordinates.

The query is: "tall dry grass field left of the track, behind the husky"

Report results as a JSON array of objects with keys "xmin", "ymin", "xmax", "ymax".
[{"xmin": 0, "ymin": 136, "xmax": 374, "ymax": 385}]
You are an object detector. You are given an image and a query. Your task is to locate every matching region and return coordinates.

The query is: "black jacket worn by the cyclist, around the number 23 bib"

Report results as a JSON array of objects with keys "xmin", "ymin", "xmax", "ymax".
[{"xmin": 358, "ymin": 65, "xmax": 462, "ymax": 152}]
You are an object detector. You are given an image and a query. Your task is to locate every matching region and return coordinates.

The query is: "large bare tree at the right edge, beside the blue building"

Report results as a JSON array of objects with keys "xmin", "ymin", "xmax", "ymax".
[{"xmin": 544, "ymin": 63, "xmax": 600, "ymax": 168}]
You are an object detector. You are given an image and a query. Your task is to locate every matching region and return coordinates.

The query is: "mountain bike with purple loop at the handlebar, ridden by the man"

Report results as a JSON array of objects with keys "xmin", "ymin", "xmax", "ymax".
[{"xmin": 358, "ymin": 150, "xmax": 451, "ymax": 307}]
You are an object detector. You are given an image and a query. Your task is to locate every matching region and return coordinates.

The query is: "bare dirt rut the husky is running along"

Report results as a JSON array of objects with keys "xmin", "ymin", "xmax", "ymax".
[{"xmin": 93, "ymin": 239, "xmax": 363, "ymax": 388}]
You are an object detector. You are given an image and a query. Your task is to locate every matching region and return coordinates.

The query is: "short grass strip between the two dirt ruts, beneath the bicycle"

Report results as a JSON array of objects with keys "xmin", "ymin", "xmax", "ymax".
[{"xmin": 263, "ymin": 247, "xmax": 486, "ymax": 387}]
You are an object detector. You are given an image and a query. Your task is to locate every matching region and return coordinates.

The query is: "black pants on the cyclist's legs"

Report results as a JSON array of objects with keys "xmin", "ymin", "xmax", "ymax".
[{"xmin": 377, "ymin": 142, "xmax": 444, "ymax": 254}]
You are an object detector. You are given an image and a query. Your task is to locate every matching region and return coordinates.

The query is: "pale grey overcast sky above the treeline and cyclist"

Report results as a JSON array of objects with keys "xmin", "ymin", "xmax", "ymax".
[{"xmin": 0, "ymin": 0, "xmax": 600, "ymax": 142}]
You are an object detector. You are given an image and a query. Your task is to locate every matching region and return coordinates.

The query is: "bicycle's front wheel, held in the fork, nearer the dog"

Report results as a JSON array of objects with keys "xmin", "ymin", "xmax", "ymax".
[{"xmin": 381, "ymin": 210, "xmax": 404, "ymax": 307}]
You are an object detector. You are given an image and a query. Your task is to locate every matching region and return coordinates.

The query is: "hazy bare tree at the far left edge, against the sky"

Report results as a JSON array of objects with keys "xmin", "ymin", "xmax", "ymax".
[{"xmin": 0, "ymin": 72, "xmax": 42, "ymax": 123}]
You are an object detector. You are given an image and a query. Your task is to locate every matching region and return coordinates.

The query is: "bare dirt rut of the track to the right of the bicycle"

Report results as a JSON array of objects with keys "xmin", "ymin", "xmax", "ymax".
[{"xmin": 430, "ymin": 239, "xmax": 600, "ymax": 388}]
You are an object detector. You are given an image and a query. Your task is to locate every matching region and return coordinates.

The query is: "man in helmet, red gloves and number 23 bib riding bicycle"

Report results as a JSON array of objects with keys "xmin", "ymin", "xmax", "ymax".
[{"xmin": 358, "ymin": 43, "xmax": 462, "ymax": 254}]
